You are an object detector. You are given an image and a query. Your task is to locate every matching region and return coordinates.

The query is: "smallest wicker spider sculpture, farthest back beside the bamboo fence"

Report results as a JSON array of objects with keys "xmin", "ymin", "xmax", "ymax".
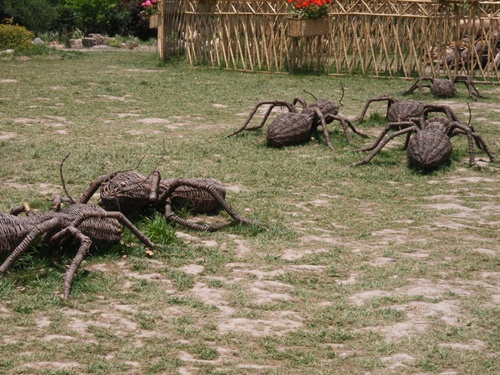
[{"xmin": 403, "ymin": 75, "xmax": 482, "ymax": 100}]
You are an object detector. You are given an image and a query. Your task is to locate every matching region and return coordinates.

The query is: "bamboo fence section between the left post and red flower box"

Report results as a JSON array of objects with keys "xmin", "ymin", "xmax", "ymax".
[{"xmin": 186, "ymin": 0, "xmax": 288, "ymax": 71}]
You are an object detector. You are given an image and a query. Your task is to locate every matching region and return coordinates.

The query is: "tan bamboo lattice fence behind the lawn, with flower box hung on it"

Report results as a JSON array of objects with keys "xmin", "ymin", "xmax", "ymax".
[{"xmin": 159, "ymin": 0, "xmax": 500, "ymax": 82}]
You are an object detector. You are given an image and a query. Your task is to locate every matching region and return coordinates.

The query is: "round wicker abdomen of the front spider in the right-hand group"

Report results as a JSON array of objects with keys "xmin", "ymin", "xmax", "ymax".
[{"xmin": 408, "ymin": 130, "xmax": 452, "ymax": 169}]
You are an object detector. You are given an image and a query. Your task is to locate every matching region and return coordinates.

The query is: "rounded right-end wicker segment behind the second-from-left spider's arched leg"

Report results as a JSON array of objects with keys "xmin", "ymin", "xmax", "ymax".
[{"xmin": 160, "ymin": 178, "xmax": 226, "ymax": 213}]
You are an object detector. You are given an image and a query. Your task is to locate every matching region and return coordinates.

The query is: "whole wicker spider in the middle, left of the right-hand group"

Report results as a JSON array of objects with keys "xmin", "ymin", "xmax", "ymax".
[{"xmin": 228, "ymin": 98, "xmax": 365, "ymax": 149}]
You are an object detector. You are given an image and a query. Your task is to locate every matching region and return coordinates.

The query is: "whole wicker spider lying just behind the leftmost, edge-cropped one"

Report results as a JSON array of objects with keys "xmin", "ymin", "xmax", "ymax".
[{"xmin": 76, "ymin": 170, "xmax": 258, "ymax": 232}]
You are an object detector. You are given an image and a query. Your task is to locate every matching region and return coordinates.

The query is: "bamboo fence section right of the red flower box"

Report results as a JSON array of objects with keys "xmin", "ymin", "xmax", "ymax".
[{"xmin": 328, "ymin": 0, "xmax": 500, "ymax": 81}]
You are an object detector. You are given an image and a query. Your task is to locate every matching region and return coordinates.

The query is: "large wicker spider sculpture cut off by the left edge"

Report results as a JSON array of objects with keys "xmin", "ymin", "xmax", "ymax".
[{"xmin": 0, "ymin": 202, "xmax": 154, "ymax": 301}]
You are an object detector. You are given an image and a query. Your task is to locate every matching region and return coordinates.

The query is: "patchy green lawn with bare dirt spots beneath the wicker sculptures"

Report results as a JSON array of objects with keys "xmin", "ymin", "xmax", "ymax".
[{"xmin": 0, "ymin": 50, "xmax": 500, "ymax": 374}]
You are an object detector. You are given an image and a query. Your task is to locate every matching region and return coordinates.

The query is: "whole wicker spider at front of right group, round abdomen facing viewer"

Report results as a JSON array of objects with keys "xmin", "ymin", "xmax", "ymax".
[{"xmin": 354, "ymin": 117, "xmax": 495, "ymax": 170}]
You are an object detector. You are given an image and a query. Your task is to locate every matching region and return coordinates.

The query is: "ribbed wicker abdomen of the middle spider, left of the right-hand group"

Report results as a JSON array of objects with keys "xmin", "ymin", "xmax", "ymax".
[{"xmin": 267, "ymin": 113, "xmax": 312, "ymax": 147}]
